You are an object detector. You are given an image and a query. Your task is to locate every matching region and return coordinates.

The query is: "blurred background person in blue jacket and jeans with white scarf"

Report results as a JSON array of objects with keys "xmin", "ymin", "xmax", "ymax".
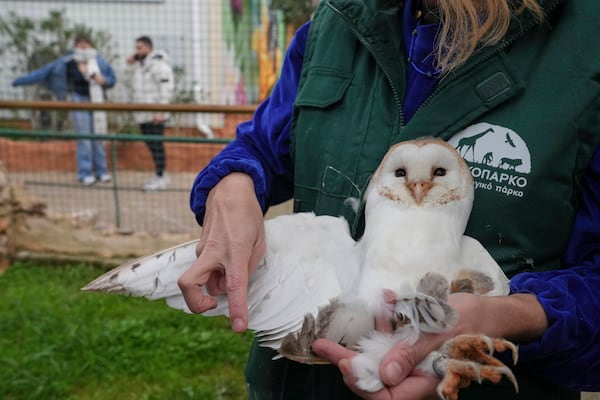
[{"xmin": 12, "ymin": 35, "xmax": 116, "ymax": 186}]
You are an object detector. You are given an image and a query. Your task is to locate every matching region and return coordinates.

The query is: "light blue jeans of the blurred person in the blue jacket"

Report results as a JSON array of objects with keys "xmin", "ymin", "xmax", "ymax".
[{"xmin": 71, "ymin": 93, "xmax": 108, "ymax": 180}]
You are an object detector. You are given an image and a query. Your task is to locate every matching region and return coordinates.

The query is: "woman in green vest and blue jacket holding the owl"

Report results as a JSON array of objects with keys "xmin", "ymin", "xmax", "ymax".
[{"xmin": 179, "ymin": 0, "xmax": 600, "ymax": 399}]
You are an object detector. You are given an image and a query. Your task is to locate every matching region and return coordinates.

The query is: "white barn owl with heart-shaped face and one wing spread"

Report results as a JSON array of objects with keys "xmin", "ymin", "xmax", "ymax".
[{"xmin": 83, "ymin": 138, "xmax": 517, "ymax": 399}]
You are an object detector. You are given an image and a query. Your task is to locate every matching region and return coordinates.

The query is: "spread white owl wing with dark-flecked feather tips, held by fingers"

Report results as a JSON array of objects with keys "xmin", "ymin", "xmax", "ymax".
[{"xmin": 83, "ymin": 213, "xmax": 359, "ymax": 348}]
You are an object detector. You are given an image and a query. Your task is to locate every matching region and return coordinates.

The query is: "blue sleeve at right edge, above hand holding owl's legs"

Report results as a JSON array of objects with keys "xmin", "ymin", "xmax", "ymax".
[{"xmin": 511, "ymin": 144, "xmax": 600, "ymax": 391}]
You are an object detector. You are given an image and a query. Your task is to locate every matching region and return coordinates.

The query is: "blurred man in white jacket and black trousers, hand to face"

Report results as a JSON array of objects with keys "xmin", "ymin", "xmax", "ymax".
[{"xmin": 127, "ymin": 36, "xmax": 175, "ymax": 191}]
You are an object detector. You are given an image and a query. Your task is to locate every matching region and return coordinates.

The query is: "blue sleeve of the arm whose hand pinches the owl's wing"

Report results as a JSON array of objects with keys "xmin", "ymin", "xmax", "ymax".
[{"xmin": 190, "ymin": 23, "xmax": 310, "ymax": 224}]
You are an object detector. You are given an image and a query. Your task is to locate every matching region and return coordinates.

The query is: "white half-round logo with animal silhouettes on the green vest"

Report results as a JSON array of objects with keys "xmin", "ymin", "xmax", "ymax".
[{"xmin": 448, "ymin": 122, "xmax": 531, "ymax": 197}]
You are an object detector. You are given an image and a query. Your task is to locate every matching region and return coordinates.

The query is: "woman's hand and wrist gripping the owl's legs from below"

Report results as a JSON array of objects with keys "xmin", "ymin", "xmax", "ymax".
[{"xmin": 313, "ymin": 293, "xmax": 548, "ymax": 400}]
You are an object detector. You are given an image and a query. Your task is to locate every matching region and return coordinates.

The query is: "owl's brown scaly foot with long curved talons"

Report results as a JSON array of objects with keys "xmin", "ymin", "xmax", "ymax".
[{"xmin": 433, "ymin": 335, "xmax": 519, "ymax": 400}]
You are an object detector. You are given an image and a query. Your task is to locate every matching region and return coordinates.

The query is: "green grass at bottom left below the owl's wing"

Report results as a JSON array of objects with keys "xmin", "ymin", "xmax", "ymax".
[{"xmin": 0, "ymin": 263, "xmax": 252, "ymax": 400}]
